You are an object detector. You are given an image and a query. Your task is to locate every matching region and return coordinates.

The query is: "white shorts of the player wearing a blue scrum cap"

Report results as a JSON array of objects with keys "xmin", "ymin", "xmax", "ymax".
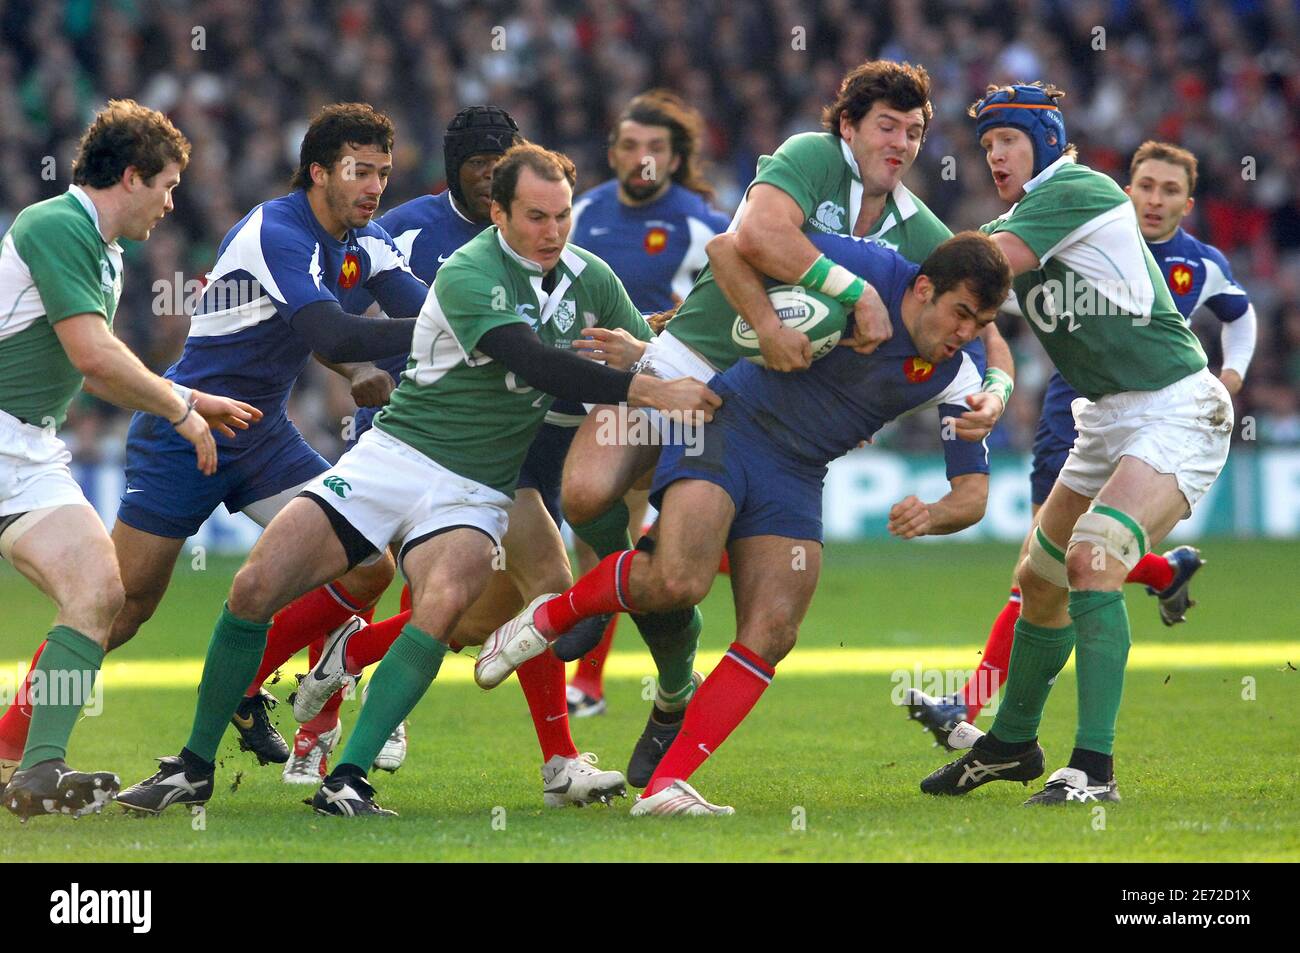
[{"xmin": 1057, "ymin": 369, "xmax": 1232, "ymax": 515}]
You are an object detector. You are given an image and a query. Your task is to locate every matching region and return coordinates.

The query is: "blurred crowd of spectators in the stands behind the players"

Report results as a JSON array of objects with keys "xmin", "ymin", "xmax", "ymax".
[{"xmin": 0, "ymin": 0, "xmax": 1300, "ymax": 459}]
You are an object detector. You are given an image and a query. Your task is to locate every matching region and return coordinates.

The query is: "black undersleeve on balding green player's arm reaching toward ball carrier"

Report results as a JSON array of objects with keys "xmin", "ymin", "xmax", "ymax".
[{"xmin": 478, "ymin": 323, "xmax": 640, "ymax": 404}]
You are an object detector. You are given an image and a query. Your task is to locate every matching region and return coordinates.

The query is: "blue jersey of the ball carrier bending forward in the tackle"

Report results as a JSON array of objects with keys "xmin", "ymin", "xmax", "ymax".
[{"xmin": 711, "ymin": 235, "xmax": 988, "ymax": 480}]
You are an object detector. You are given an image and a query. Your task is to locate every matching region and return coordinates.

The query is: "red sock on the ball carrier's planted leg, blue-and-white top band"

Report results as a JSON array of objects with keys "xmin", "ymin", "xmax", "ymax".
[{"xmin": 646, "ymin": 642, "xmax": 776, "ymax": 797}]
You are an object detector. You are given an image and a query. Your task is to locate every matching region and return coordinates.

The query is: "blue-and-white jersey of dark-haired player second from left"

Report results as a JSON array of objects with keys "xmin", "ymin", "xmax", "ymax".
[{"xmin": 164, "ymin": 190, "xmax": 429, "ymax": 446}]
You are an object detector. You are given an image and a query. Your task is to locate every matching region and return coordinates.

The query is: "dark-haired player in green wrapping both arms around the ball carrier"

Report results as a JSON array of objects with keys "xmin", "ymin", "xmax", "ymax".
[{"xmin": 533, "ymin": 61, "xmax": 1011, "ymax": 787}]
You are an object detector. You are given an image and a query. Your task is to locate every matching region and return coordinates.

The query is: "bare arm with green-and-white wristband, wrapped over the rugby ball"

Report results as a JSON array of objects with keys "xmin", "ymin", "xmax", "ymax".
[{"xmin": 738, "ymin": 182, "xmax": 893, "ymax": 354}]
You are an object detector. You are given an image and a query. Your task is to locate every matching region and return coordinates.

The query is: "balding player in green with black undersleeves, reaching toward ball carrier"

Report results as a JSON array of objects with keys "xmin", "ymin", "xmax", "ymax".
[{"xmin": 115, "ymin": 144, "xmax": 720, "ymax": 816}]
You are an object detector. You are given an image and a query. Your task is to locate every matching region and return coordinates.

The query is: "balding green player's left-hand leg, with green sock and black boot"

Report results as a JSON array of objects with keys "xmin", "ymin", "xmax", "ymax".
[{"xmin": 118, "ymin": 497, "xmax": 361, "ymax": 813}]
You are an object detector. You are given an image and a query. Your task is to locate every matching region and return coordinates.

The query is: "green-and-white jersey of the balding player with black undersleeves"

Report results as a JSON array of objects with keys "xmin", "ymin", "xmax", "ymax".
[{"xmin": 374, "ymin": 226, "xmax": 651, "ymax": 494}]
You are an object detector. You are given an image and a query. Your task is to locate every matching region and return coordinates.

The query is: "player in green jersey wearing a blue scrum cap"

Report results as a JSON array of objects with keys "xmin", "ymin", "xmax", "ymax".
[{"xmin": 920, "ymin": 83, "xmax": 1232, "ymax": 803}]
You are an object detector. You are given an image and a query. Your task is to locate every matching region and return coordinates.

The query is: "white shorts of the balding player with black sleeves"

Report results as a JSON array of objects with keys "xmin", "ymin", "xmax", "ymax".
[{"xmin": 303, "ymin": 428, "xmax": 514, "ymax": 553}]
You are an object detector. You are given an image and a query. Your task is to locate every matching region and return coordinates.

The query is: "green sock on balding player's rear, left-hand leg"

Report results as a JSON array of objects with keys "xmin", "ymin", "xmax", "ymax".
[{"xmin": 185, "ymin": 605, "xmax": 270, "ymax": 761}]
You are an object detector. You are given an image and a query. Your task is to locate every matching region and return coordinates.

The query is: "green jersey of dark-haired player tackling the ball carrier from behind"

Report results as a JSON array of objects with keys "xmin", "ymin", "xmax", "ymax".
[{"xmin": 668, "ymin": 133, "xmax": 953, "ymax": 371}]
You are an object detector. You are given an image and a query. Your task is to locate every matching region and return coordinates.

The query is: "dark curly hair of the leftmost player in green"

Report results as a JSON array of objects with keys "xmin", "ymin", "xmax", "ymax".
[{"xmin": 73, "ymin": 99, "xmax": 190, "ymax": 189}]
